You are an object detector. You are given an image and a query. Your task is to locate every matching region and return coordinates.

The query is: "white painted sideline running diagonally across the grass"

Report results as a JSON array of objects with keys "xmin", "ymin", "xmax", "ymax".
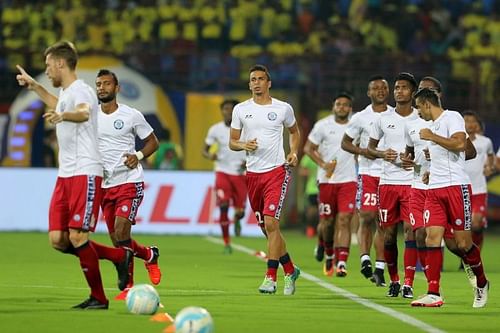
[{"xmin": 206, "ymin": 236, "xmax": 445, "ymax": 333}]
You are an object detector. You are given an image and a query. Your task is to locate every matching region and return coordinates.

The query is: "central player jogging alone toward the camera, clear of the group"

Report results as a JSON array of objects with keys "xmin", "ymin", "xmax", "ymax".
[{"xmin": 229, "ymin": 65, "xmax": 300, "ymax": 295}]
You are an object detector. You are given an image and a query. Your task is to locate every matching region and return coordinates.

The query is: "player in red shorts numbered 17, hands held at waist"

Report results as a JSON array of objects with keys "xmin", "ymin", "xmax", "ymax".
[{"xmin": 368, "ymin": 73, "xmax": 418, "ymax": 298}]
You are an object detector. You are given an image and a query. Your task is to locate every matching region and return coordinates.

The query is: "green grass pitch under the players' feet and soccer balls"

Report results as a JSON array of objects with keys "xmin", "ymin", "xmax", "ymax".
[{"xmin": 0, "ymin": 232, "xmax": 500, "ymax": 333}]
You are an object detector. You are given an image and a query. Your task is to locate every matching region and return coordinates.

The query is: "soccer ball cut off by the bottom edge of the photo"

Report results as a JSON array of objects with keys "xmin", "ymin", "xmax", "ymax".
[{"xmin": 174, "ymin": 306, "xmax": 214, "ymax": 333}]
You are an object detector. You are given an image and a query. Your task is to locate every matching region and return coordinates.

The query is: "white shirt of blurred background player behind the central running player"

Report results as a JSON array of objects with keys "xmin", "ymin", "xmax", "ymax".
[{"xmin": 205, "ymin": 121, "xmax": 246, "ymax": 175}]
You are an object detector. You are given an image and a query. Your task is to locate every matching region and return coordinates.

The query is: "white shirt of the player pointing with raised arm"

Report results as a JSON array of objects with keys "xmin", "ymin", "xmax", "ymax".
[{"xmin": 56, "ymin": 80, "xmax": 102, "ymax": 177}]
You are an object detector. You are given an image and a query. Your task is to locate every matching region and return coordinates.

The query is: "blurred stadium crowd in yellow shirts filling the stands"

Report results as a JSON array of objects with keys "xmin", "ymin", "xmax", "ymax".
[{"xmin": 0, "ymin": 0, "xmax": 500, "ymax": 117}]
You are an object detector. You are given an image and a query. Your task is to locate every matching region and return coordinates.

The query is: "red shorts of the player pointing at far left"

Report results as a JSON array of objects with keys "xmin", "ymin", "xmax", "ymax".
[{"xmin": 49, "ymin": 175, "xmax": 102, "ymax": 231}]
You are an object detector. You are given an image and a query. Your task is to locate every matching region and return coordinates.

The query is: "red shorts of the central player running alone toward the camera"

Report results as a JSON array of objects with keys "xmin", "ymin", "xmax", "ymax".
[{"xmin": 247, "ymin": 165, "xmax": 292, "ymax": 224}]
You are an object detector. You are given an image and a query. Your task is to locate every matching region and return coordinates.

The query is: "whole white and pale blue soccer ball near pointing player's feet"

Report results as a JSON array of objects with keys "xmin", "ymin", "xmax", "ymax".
[{"xmin": 125, "ymin": 284, "xmax": 160, "ymax": 314}]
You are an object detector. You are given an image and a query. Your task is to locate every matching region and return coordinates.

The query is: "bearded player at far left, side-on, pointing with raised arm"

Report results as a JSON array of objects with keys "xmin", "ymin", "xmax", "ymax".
[{"xmin": 16, "ymin": 42, "xmax": 132, "ymax": 309}]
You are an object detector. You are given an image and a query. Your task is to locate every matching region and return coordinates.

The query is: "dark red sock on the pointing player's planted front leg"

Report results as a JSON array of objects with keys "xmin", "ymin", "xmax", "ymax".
[{"xmin": 75, "ymin": 242, "xmax": 108, "ymax": 303}]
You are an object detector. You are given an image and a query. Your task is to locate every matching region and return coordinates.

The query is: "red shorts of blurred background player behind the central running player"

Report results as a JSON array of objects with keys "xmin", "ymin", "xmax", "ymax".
[{"xmin": 215, "ymin": 171, "xmax": 247, "ymax": 208}]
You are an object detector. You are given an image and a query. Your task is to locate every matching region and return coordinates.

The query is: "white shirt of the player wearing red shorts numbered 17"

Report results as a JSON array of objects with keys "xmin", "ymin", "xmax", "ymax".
[{"xmin": 370, "ymin": 109, "xmax": 418, "ymax": 185}]
